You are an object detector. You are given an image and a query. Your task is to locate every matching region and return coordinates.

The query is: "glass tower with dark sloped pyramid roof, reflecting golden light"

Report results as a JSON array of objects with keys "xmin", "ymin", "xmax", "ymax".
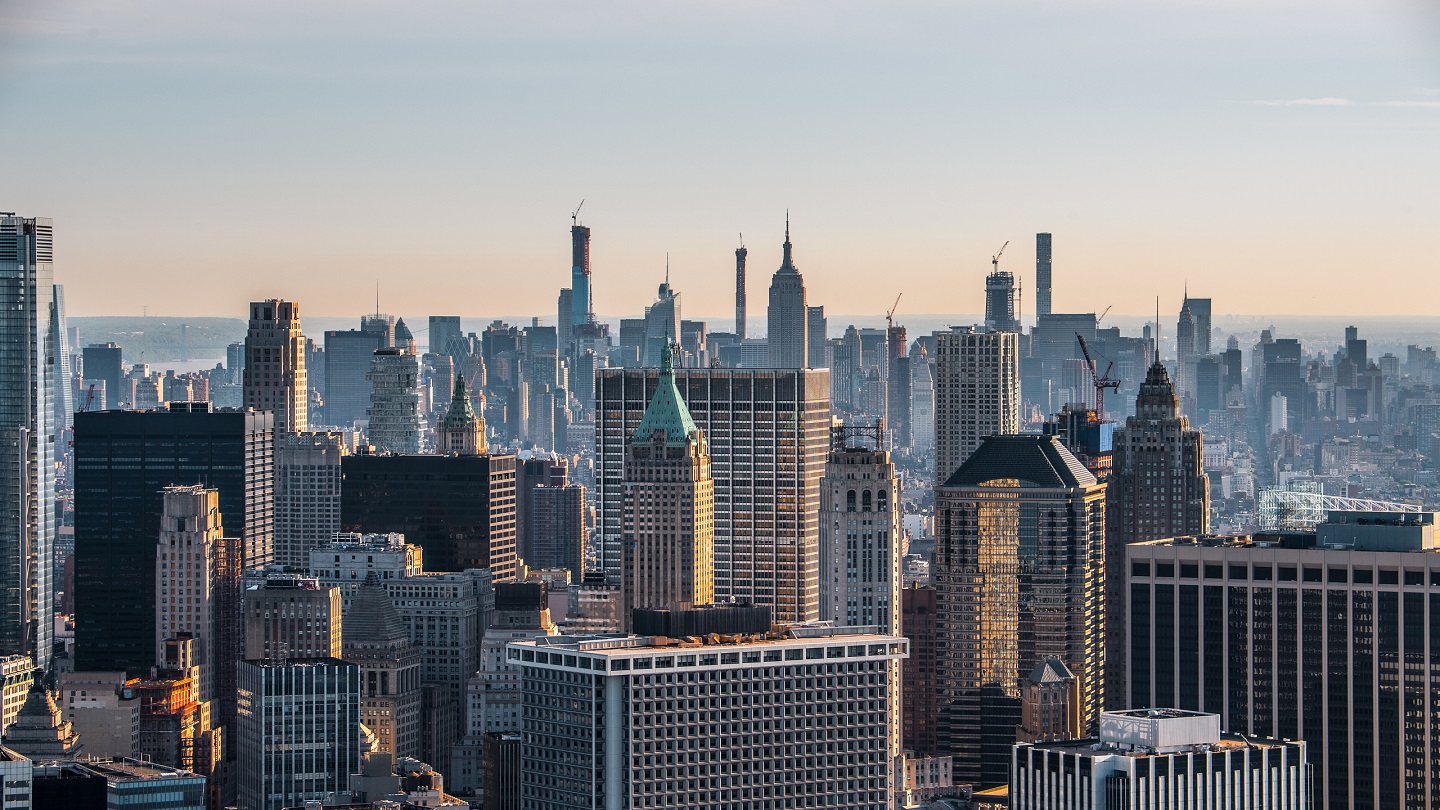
[{"xmin": 933, "ymin": 435, "xmax": 1104, "ymax": 785}]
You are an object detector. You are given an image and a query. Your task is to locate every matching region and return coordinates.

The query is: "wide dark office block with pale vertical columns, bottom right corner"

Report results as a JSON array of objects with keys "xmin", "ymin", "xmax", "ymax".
[{"xmin": 1126, "ymin": 512, "xmax": 1440, "ymax": 809}]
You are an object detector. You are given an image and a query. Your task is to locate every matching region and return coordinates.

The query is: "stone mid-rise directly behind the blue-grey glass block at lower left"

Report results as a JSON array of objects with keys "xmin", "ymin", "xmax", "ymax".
[{"xmin": 245, "ymin": 574, "xmax": 343, "ymax": 662}]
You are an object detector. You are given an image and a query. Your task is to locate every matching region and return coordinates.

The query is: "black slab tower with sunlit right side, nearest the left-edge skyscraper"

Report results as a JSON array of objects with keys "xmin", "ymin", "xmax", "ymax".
[{"xmin": 75, "ymin": 402, "xmax": 275, "ymax": 677}]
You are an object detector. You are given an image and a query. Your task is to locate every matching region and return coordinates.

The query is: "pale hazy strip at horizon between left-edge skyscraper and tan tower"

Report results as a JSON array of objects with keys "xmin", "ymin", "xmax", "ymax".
[{"xmin": 68, "ymin": 316, "xmax": 248, "ymax": 363}]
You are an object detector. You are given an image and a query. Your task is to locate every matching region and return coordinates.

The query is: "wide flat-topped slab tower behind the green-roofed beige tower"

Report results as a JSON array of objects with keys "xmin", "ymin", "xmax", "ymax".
[{"xmin": 595, "ymin": 369, "xmax": 831, "ymax": 621}]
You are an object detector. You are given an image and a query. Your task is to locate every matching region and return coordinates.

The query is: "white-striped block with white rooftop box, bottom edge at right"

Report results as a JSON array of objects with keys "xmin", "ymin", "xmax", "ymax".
[{"xmin": 1009, "ymin": 709, "xmax": 1310, "ymax": 810}]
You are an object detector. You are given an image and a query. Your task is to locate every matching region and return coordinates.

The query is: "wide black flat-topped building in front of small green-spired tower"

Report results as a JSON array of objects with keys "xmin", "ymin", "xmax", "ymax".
[{"xmin": 340, "ymin": 455, "xmax": 517, "ymax": 582}]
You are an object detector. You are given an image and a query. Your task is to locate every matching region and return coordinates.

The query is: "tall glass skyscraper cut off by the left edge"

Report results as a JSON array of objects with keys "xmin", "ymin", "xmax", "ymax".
[{"xmin": 0, "ymin": 213, "xmax": 55, "ymax": 670}]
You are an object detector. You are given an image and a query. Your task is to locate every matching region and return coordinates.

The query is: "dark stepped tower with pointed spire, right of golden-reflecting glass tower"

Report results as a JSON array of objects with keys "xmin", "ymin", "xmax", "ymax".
[{"xmin": 1100, "ymin": 360, "xmax": 1210, "ymax": 711}]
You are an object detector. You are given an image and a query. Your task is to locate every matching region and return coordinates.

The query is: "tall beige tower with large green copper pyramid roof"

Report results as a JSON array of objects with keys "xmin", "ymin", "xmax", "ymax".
[{"xmin": 622, "ymin": 343, "xmax": 714, "ymax": 616}]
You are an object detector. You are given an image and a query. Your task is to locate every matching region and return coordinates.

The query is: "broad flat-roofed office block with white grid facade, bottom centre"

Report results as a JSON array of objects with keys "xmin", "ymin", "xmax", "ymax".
[{"xmin": 508, "ymin": 616, "xmax": 909, "ymax": 810}]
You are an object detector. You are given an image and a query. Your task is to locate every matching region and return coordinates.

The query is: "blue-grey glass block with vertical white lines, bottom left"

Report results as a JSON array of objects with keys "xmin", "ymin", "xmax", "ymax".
[{"xmin": 235, "ymin": 657, "xmax": 361, "ymax": 810}]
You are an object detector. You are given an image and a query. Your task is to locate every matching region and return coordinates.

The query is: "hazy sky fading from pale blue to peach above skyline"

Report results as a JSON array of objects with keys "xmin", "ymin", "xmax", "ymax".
[{"xmin": 0, "ymin": 0, "xmax": 1440, "ymax": 318}]
